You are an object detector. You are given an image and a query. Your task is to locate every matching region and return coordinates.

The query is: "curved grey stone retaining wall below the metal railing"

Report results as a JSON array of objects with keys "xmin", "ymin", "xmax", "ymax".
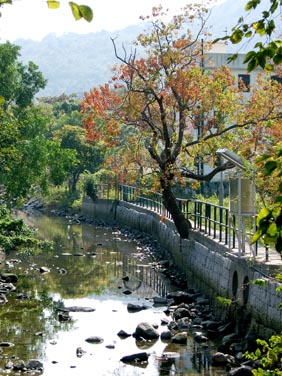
[{"xmin": 83, "ymin": 199, "xmax": 282, "ymax": 334}]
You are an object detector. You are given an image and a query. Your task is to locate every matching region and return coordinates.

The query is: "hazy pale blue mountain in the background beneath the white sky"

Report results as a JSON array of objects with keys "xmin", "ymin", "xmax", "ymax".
[{"xmin": 14, "ymin": 0, "xmax": 264, "ymax": 96}]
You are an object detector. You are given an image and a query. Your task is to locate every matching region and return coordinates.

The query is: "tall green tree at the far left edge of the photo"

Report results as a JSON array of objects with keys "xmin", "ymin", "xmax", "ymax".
[{"xmin": 0, "ymin": 43, "xmax": 48, "ymax": 205}]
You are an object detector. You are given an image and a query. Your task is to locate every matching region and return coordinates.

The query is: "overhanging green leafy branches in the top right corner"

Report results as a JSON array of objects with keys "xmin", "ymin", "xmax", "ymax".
[{"xmin": 215, "ymin": 0, "xmax": 282, "ymax": 71}]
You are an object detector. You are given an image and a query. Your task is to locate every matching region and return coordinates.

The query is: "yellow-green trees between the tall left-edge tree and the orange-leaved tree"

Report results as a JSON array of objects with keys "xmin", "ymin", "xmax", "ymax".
[{"xmin": 36, "ymin": 93, "xmax": 105, "ymax": 192}]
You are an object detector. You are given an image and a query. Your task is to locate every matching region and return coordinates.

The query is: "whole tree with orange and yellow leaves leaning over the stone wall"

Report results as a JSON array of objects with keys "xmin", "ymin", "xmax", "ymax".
[{"xmin": 80, "ymin": 5, "xmax": 281, "ymax": 238}]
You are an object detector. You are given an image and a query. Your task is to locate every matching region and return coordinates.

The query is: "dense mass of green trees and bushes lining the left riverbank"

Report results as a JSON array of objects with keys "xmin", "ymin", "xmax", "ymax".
[{"xmin": 0, "ymin": 42, "xmax": 105, "ymax": 250}]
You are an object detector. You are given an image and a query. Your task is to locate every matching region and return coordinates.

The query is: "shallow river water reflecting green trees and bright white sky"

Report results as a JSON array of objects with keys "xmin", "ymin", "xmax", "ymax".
[{"xmin": 0, "ymin": 214, "xmax": 226, "ymax": 376}]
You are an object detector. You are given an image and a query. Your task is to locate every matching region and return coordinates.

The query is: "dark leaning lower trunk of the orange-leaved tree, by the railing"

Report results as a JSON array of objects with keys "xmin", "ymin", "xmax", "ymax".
[{"xmin": 161, "ymin": 178, "xmax": 192, "ymax": 239}]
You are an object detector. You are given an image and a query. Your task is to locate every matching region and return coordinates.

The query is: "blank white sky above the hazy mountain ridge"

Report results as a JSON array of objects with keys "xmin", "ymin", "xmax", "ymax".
[{"xmin": 0, "ymin": 0, "xmax": 224, "ymax": 42}]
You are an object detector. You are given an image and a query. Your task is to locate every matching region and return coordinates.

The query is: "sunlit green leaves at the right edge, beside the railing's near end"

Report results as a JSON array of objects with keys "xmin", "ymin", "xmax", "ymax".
[{"xmin": 252, "ymin": 145, "xmax": 282, "ymax": 257}]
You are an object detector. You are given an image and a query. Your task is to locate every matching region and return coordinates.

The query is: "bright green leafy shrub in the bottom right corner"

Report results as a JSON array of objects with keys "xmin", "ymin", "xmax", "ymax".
[{"xmin": 244, "ymin": 335, "xmax": 282, "ymax": 376}]
